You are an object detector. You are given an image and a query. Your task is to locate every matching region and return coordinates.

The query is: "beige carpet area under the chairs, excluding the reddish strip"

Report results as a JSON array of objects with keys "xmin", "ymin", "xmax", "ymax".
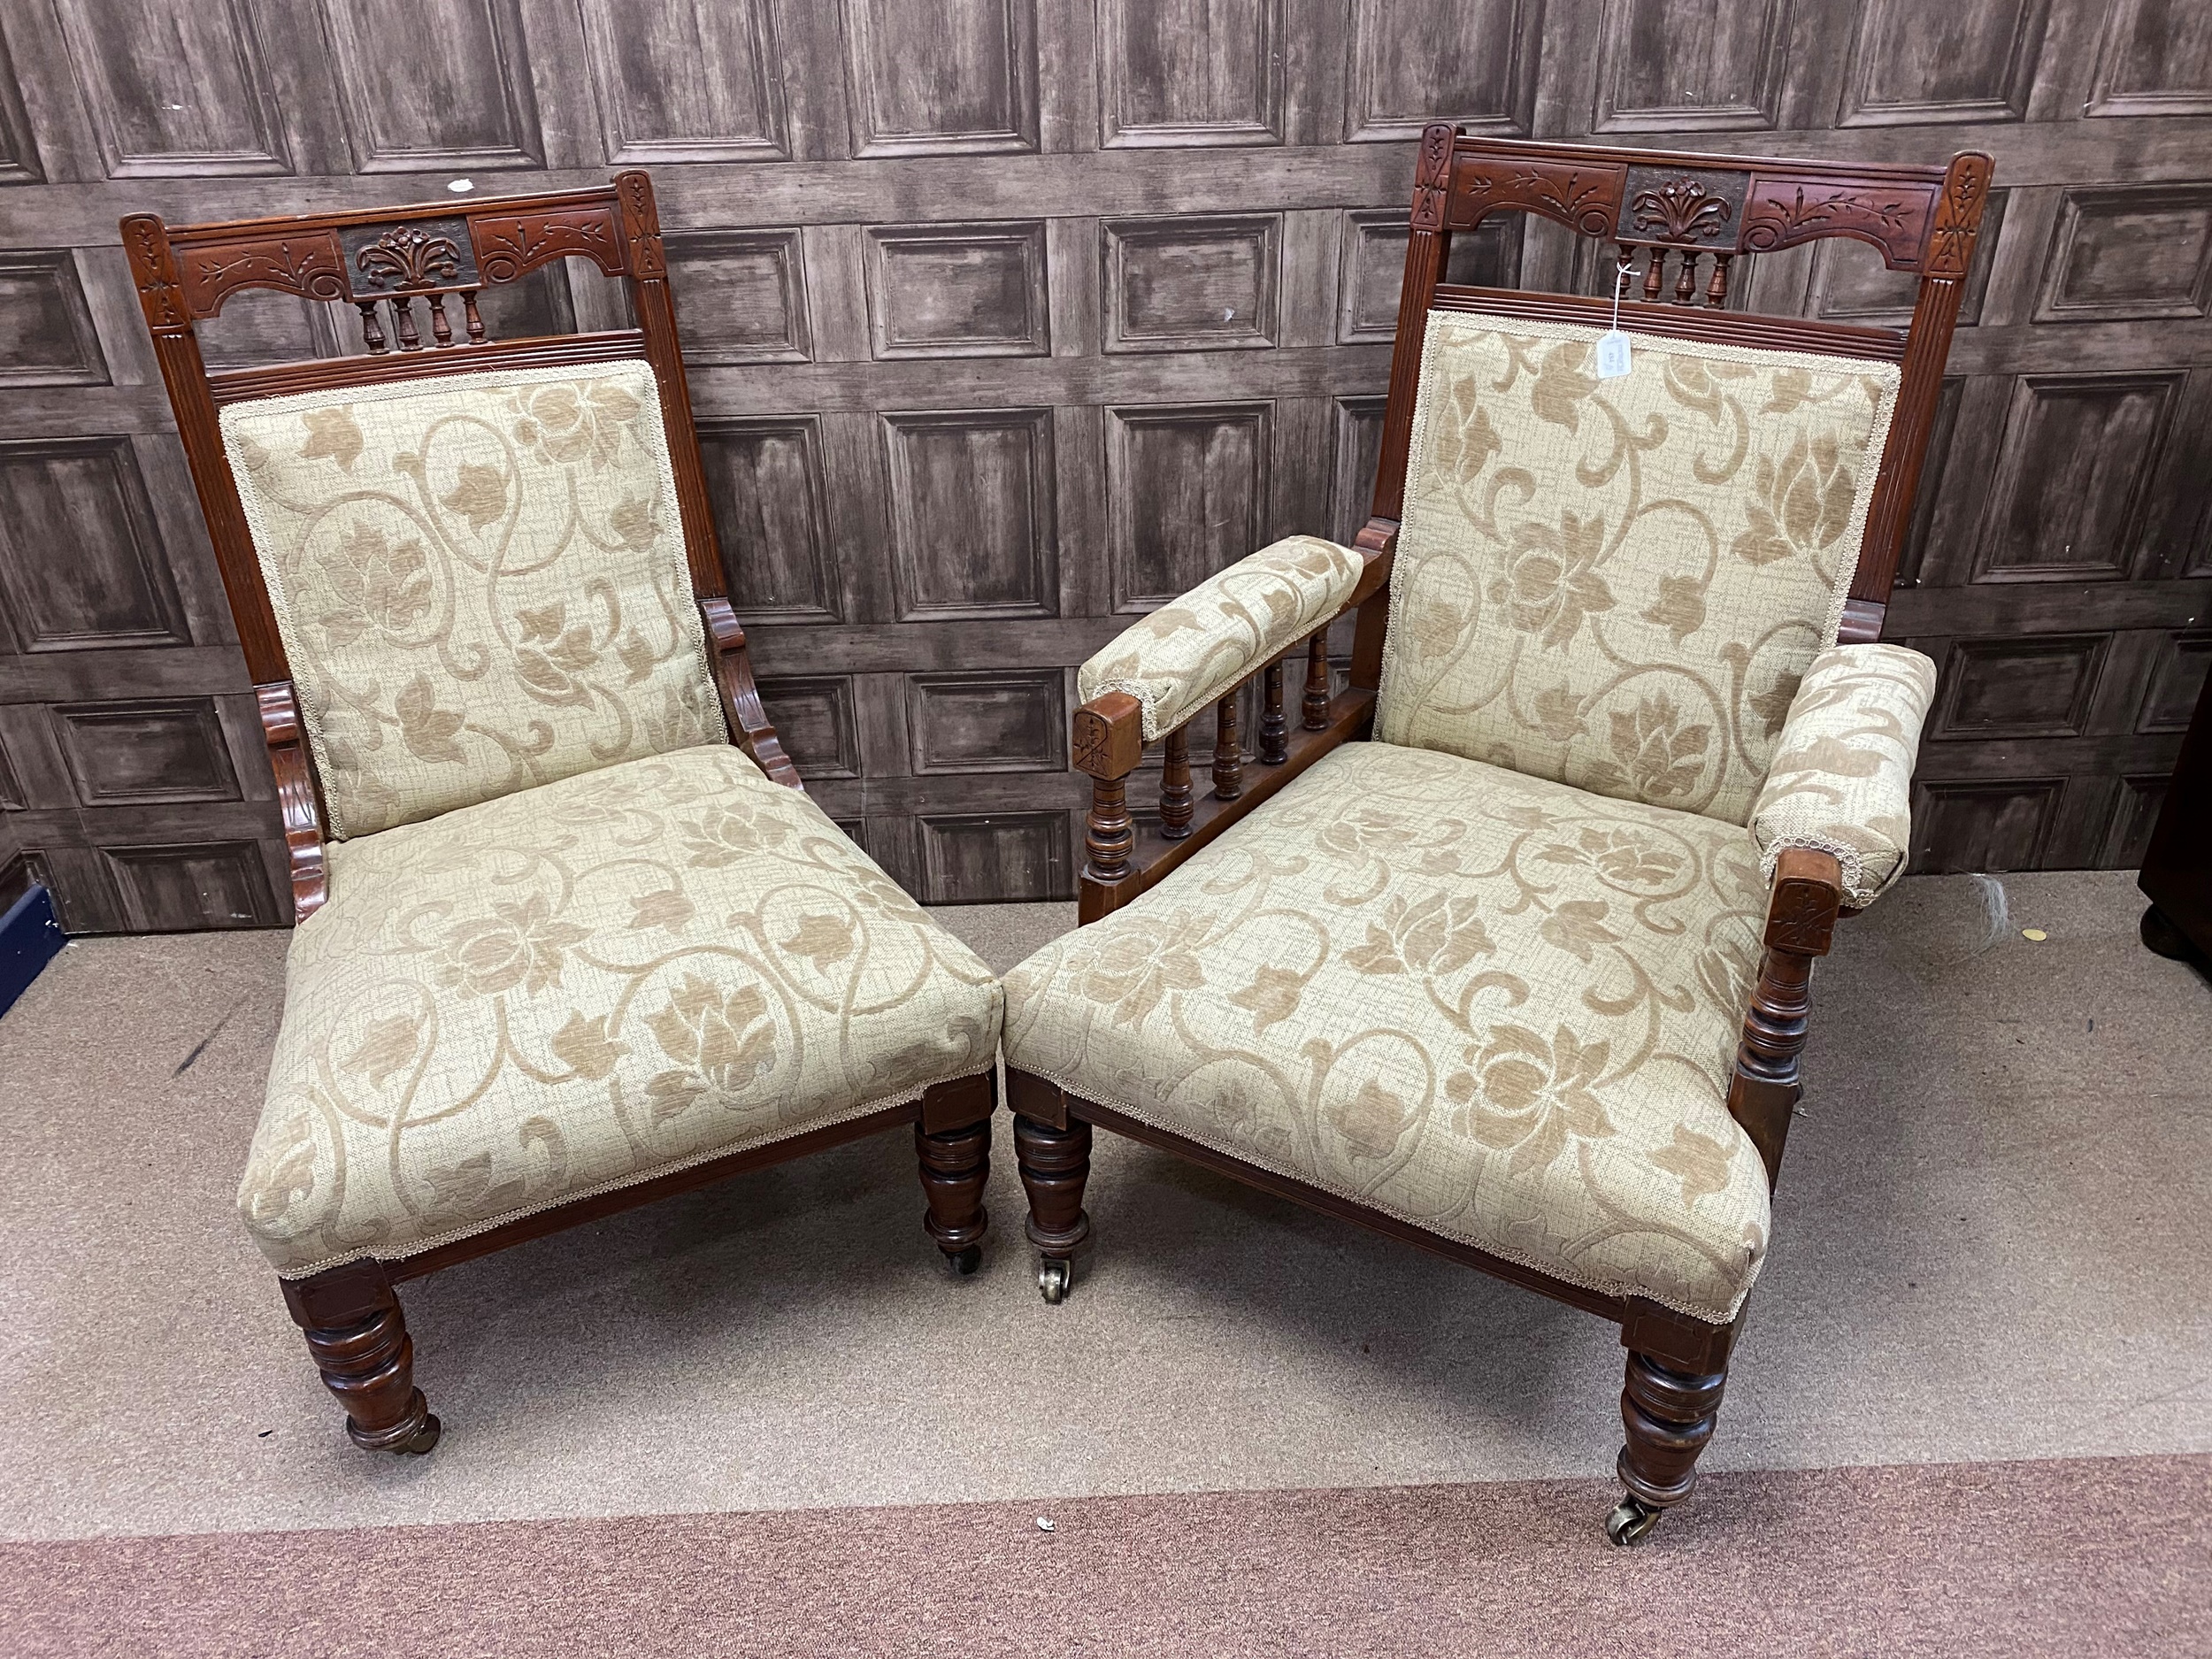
[{"xmin": 0, "ymin": 874, "xmax": 2212, "ymax": 1540}]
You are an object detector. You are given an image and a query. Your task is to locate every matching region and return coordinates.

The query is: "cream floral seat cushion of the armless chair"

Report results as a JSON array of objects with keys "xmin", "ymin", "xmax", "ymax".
[{"xmin": 239, "ymin": 746, "xmax": 1000, "ymax": 1277}]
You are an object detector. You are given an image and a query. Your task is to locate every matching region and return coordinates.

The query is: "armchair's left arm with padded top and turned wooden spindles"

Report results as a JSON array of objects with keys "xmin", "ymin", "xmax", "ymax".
[{"xmin": 1073, "ymin": 520, "xmax": 1398, "ymax": 923}]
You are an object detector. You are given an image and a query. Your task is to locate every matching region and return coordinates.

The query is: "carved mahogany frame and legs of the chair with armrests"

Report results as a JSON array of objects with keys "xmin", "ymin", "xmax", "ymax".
[{"xmin": 1007, "ymin": 122, "xmax": 1991, "ymax": 1544}]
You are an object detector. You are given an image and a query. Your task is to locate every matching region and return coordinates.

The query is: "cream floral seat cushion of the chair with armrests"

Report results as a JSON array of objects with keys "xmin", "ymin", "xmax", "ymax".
[{"xmin": 1007, "ymin": 743, "xmax": 1768, "ymax": 1321}]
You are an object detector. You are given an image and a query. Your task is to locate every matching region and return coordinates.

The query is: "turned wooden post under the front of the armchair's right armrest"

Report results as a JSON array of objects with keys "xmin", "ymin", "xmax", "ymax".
[{"xmin": 1728, "ymin": 848, "xmax": 1843, "ymax": 1188}]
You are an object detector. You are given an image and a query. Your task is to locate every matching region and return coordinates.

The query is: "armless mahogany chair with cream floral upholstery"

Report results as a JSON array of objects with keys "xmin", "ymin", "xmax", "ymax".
[{"xmin": 122, "ymin": 171, "xmax": 1000, "ymax": 1451}]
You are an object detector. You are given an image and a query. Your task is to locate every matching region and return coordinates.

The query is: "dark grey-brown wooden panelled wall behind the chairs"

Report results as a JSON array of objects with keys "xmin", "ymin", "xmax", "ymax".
[{"xmin": 0, "ymin": 0, "xmax": 2212, "ymax": 932}]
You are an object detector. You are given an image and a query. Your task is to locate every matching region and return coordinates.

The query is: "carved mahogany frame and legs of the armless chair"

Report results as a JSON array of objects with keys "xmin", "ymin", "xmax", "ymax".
[{"xmin": 122, "ymin": 168, "xmax": 998, "ymax": 1451}]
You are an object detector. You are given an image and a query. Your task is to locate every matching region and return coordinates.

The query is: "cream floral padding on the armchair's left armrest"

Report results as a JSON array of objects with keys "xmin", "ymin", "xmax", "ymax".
[{"xmin": 1075, "ymin": 535, "xmax": 1363, "ymax": 743}]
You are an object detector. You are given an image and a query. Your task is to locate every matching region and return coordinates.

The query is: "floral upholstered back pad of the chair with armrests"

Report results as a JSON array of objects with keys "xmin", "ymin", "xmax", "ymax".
[{"xmin": 1376, "ymin": 312, "xmax": 1898, "ymax": 823}]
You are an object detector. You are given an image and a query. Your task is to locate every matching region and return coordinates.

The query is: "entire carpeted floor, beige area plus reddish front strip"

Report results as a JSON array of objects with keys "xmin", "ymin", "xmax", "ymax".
[{"xmin": 0, "ymin": 874, "xmax": 2212, "ymax": 1653}]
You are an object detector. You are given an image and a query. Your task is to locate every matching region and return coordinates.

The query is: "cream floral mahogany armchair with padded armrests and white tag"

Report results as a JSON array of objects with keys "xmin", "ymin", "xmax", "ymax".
[{"xmin": 1004, "ymin": 124, "xmax": 1991, "ymax": 1544}]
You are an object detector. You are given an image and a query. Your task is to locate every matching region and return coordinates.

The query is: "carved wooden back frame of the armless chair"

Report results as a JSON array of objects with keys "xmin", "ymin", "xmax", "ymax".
[{"xmin": 122, "ymin": 168, "xmax": 799, "ymax": 916}]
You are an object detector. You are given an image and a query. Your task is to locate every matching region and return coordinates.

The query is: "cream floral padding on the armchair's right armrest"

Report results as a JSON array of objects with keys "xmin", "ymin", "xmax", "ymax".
[{"xmin": 1752, "ymin": 646, "xmax": 1936, "ymax": 905}]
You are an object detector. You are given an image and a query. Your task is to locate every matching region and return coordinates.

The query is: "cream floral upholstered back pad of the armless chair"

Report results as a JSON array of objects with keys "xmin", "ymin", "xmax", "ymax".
[{"xmin": 224, "ymin": 363, "xmax": 726, "ymax": 841}]
